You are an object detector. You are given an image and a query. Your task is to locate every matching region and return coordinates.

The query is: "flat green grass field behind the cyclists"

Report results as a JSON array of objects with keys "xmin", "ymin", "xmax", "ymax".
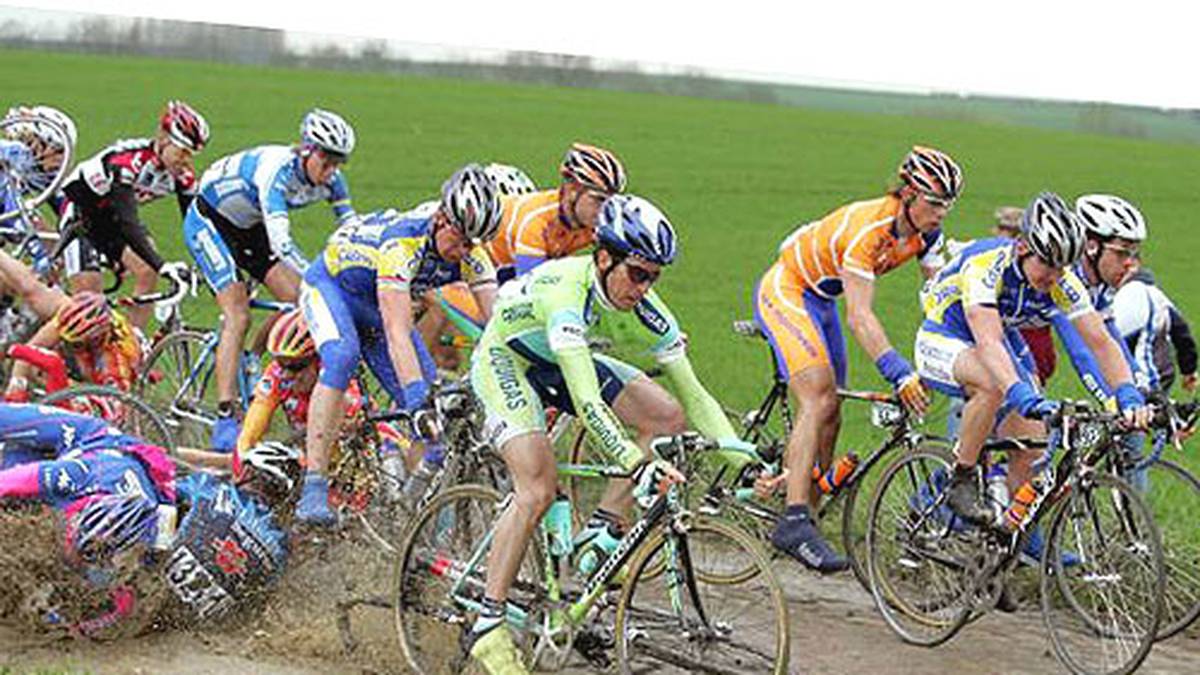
[{"xmin": 0, "ymin": 45, "xmax": 1200, "ymax": 456}]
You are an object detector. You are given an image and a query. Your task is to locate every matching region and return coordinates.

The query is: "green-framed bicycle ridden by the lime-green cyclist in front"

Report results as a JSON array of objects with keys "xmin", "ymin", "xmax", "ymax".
[{"xmin": 392, "ymin": 434, "xmax": 788, "ymax": 674}]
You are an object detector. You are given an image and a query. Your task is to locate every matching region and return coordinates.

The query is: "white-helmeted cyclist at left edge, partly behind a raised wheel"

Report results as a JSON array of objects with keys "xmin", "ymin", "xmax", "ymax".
[{"xmin": 0, "ymin": 106, "xmax": 78, "ymax": 270}]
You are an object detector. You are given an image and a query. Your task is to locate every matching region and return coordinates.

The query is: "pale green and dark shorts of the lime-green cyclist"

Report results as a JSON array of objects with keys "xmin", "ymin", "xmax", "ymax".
[{"xmin": 470, "ymin": 345, "xmax": 644, "ymax": 449}]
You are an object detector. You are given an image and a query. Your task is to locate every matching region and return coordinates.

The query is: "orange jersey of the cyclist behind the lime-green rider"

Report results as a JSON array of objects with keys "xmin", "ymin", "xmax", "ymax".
[{"xmin": 487, "ymin": 187, "xmax": 595, "ymax": 274}]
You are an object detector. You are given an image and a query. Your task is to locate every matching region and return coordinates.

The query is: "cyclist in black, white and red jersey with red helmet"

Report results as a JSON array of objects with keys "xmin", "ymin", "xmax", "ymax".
[{"xmin": 59, "ymin": 101, "xmax": 209, "ymax": 329}]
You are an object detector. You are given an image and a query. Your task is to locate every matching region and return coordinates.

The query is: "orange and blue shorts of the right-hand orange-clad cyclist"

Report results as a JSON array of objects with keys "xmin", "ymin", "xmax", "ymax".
[{"xmin": 754, "ymin": 263, "xmax": 847, "ymax": 387}]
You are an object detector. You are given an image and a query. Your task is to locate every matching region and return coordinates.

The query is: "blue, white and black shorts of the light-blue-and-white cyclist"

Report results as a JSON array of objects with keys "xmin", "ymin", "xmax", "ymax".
[{"xmin": 184, "ymin": 197, "xmax": 280, "ymax": 293}]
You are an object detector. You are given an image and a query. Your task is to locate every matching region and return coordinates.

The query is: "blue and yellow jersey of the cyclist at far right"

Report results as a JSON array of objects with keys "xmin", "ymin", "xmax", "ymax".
[{"xmin": 920, "ymin": 237, "xmax": 1093, "ymax": 342}]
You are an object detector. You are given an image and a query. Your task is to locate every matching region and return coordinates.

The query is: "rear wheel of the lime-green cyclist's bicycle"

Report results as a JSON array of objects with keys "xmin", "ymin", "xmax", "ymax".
[{"xmin": 392, "ymin": 485, "xmax": 544, "ymax": 674}]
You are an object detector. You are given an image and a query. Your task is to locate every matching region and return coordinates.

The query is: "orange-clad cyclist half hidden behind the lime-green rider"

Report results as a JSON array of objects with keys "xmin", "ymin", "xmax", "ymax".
[{"xmin": 487, "ymin": 143, "xmax": 625, "ymax": 281}]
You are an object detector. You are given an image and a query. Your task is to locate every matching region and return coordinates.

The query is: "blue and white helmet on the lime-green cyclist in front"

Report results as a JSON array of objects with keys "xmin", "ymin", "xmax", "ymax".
[{"xmin": 596, "ymin": 195, "xmax": 677, "ymax": 265}]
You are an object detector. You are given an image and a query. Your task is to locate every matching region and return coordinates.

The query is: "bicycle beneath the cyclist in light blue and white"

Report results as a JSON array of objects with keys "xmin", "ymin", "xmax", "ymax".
[{"xmin": 137, "ymin": 274, "xmax": 292, "ymax": 448}]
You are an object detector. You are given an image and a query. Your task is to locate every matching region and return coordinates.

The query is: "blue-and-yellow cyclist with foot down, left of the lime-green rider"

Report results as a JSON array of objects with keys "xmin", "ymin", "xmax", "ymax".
[{"xmin": 296, "ymin": 165, "xmax": 499, "ymax": 524}]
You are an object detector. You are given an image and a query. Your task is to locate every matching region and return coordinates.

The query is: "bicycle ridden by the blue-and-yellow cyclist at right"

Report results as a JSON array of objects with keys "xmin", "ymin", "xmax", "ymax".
[{"xmin": 866, "ymin": 401, "xmax": 1165, "ymax": 673}]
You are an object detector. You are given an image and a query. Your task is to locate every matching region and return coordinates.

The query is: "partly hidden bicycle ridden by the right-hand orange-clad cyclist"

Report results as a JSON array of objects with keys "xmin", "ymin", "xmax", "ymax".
[{"xmin": 569, "ymin": 321, "xmax": 950, "ymax": 591}]
